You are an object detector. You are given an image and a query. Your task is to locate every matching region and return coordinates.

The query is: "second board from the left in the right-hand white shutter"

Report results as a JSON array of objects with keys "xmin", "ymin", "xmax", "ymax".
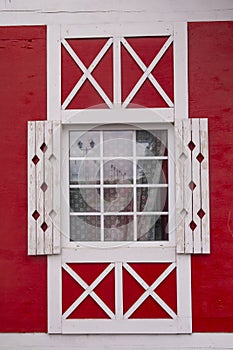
[{"xmin": 183, "ymin": 119, "xmax": 193, "ymax": 254}]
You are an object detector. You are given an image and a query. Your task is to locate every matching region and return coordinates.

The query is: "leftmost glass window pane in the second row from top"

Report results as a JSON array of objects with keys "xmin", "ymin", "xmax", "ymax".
[{"xmin": 70, "ymin": 160, "xmax": 100, "ymax": 185}]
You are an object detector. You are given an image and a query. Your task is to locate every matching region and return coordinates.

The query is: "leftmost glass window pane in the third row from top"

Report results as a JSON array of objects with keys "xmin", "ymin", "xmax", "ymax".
[{"xmin": 70, "ymin": 188, "xmax": 100, "ymax": 212}]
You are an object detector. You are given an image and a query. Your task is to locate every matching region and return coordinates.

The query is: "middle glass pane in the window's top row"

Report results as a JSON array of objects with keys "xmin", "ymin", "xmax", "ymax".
[{"xmin": 103, "ymin": 130, "xmax": 133, "ymax": 157}]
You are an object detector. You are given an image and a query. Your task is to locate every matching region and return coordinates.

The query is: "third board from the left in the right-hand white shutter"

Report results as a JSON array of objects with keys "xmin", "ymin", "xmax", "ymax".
[{"xmin": 191, "ymin": 118, "xmax": 201, "ymax": 253}]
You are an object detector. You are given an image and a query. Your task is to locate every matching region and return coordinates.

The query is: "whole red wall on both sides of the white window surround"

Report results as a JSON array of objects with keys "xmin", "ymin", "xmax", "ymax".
[{"xmin": 0, "ymin": 22, "xmax": 233, "ymax": 332}]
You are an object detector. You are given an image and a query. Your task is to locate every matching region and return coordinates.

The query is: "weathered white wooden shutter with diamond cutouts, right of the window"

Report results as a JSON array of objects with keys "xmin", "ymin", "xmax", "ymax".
[{"xmin": 175, "ymin": 118, "xmax": 210, "ymax": 254}]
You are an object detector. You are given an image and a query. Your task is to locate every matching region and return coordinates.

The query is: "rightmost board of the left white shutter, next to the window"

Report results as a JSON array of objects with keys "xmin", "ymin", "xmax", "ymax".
[{"xmin": 52, "ymin": 121, "xmax": 62, "ymax": 254}]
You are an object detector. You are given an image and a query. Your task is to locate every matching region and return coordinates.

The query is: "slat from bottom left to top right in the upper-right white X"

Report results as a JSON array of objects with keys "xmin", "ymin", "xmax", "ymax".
[{"xmin": 122, "ymin": 35, "xmax": 173, "ymax": 108}]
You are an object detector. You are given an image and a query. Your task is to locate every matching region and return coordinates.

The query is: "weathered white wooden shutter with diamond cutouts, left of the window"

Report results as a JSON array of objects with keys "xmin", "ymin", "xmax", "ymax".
[{"xmin": 28, "ymin": 121, "xmax": 61, "ymax": 255}]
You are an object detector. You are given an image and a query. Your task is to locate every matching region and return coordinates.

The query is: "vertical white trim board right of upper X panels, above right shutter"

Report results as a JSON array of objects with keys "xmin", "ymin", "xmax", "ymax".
[{"xmin": 174, "ymin": 22, "xmax": 188, "ymax": 119}]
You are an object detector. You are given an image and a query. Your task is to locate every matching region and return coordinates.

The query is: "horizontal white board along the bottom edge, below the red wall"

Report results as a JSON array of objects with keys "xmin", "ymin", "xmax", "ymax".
[{"xmin": 0, "ymin": 333, "xmax": 233, "ymax": 350}]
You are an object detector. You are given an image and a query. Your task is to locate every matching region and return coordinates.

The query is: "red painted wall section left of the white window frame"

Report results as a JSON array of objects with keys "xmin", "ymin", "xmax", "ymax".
[{"xmin": 0, "ymin": 27, "xmax": 47, "ymax": 332}]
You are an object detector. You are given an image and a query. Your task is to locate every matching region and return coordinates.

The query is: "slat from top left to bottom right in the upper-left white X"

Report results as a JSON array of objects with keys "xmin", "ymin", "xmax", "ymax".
[{"xmin": 62, "ymin": 39, "xmax": 113, "ymax": 108}]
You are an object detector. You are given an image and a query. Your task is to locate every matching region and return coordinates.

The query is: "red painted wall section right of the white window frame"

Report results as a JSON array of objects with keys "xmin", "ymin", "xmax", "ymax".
[{"xmin": 189, "ymin": 22, "xmax": 233, "ymax": 332}]
